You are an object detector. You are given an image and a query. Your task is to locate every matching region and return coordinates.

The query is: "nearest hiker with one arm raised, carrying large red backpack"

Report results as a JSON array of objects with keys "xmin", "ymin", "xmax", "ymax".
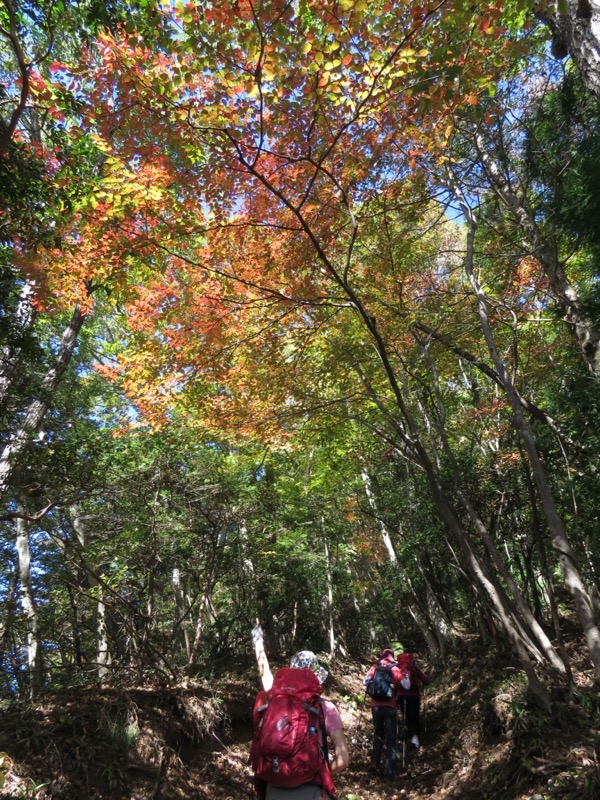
[{"xmin": 250, "ymin": 626, "xmax": 349, "ymax": 800}]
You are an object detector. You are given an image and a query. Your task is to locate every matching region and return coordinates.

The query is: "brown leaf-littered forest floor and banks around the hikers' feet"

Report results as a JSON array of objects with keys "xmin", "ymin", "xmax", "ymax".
[{"xmin": 0, "ymin": 642, "xmax": 600, "ymax": 800}]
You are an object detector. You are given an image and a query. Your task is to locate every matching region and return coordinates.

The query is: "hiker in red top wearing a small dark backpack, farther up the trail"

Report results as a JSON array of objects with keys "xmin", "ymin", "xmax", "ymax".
[{"xmin": 363, "ymin": 648, "xmax": 402, "ymax": 779}]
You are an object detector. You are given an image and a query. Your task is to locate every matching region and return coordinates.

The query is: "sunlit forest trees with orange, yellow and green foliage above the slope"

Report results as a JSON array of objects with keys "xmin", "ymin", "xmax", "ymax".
[{"xmin": 0, "ymin": 0, "xmax": 600, "ymax": 710}]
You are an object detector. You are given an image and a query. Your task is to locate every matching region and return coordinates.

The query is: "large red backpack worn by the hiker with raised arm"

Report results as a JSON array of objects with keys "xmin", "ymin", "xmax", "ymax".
[{"xmin": 250, "ymin": 667, "xmax": 336, "ymax": 797}]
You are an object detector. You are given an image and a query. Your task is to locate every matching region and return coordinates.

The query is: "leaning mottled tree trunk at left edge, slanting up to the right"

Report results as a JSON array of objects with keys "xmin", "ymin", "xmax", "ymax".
[{"xmin": 0, "ymin": 306, "xmax": 85, "ymax": 499}]
